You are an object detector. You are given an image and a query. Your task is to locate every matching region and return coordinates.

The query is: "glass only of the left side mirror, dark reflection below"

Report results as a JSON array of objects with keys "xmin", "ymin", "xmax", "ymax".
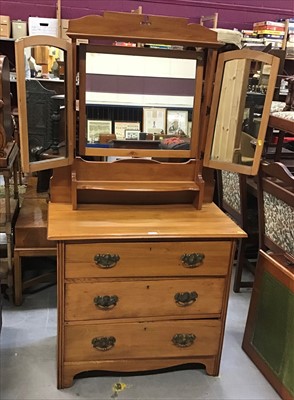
[{"xmin": 25, "ymin": 46, "xmax": 66, "ymax": 162}]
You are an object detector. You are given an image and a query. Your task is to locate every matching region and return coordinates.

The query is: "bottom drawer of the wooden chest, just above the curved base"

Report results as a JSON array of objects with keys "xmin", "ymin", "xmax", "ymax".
[{"xmin": 64, "ymin": 320, "xmax": 221, "ymax": 362}]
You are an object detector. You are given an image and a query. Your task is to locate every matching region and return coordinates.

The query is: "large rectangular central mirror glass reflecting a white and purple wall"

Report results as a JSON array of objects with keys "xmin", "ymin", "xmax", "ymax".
[{"xmin": 80, "ymin": 46, "xmax": 197, "ymax": 150}]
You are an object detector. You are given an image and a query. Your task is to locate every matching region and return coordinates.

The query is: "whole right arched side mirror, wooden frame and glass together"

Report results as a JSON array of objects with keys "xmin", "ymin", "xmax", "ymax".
[{"xmin": 204, "ymin": 50, "xmax": 278, "ymax": 175}]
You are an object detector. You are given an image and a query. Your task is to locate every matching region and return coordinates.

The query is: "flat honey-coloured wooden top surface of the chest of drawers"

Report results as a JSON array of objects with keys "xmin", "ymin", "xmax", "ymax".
[{"xmin": 48, "ymin": 203, "xmax": 246, "ymax": 240}]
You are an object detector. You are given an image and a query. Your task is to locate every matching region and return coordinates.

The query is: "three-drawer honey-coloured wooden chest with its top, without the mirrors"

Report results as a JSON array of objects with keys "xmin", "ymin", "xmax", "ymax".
[{"xmin": 48, "ymin": 204, "xmax": 243, "ymax": 387}]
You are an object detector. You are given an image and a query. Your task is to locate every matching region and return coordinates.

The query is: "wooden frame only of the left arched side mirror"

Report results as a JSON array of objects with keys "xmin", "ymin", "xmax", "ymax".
[{"xmin": 15, "ymin": 36, "xmax": 74, "ymax": 173}]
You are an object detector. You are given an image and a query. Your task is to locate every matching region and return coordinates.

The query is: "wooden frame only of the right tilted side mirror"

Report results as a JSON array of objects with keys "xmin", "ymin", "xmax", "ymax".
[{"xmin": 203, "ymin": 49, "xmax": 280, "ymax": 175}]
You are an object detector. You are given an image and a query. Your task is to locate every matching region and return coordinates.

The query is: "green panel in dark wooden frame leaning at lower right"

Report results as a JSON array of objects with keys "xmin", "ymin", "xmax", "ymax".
[{"xmin": 242, "ymin": 250, "xmax": 294, "ymax": 400}]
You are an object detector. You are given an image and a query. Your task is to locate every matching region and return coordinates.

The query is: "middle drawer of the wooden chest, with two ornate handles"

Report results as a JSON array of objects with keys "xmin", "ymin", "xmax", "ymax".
[{"xmin": 65, "ymin": 278, "xmax": 225, "ymax": 321}]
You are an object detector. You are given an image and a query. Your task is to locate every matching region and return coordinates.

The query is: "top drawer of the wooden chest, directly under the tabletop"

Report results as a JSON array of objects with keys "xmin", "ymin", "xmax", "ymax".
[{"xmin": 65, "ymin": 241, "xmax": 232, "ymax": 278}]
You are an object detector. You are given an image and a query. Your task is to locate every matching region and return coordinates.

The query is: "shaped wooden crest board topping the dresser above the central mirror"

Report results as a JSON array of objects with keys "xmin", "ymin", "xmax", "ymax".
[{"xmin": 67, "ymin": 12, "xmax": 221, "ymax": 48}]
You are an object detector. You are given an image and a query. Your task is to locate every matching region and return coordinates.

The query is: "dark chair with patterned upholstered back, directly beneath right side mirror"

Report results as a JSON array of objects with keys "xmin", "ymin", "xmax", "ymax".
[{"xmin": 217, "ymin": 171, "xmax": 258, "ymax": 293}]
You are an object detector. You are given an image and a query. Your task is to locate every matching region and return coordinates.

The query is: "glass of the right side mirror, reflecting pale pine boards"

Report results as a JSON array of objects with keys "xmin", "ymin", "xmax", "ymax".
[{"xmin": 210, "ymin": 59, "xmax": 271, "ymax": 166}]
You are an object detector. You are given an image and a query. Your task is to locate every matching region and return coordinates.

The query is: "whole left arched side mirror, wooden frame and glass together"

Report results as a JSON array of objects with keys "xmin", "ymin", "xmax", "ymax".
[{"xmin": 15, "ymin": 36, "xmax": 73, "ymax": 172}]
